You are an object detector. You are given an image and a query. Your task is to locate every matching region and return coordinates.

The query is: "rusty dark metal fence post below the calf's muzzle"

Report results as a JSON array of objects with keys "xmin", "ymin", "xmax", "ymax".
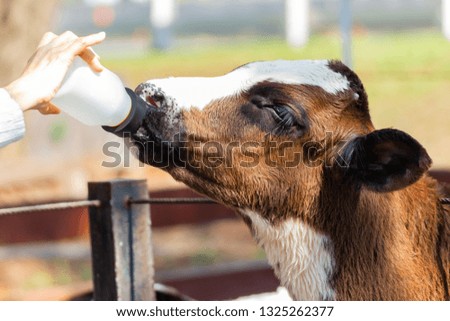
[{"xmin": 89, "ymin": 180, "xmax": 155, "ymax": 301}]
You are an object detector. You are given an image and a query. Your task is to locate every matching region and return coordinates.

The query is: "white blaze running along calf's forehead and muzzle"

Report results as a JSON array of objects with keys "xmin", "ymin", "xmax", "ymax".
[{"xmin": 139, "ymin": 60, "xmax": 350, "ymax": 109}]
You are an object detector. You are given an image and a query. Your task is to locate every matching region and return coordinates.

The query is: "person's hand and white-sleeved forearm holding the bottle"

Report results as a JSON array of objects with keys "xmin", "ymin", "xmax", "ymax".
[{"xmin": 0, "ymin": 32, "xmax": 105, "ymax": 148}]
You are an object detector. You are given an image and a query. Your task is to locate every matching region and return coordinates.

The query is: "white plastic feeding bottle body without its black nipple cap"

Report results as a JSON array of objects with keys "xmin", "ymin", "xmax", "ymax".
[{"xmin": 52, "ymin": 57, "xmax": 131, "ymax": 127}]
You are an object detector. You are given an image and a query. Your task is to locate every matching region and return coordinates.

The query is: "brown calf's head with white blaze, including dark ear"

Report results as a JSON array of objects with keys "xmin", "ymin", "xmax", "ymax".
[{"xmin": 133, "ymin": 61, "xmax": 431, "ymax": 220}]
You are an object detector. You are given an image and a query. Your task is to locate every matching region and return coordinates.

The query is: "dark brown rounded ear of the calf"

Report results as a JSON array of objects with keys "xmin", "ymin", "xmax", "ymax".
[{"xmin": 341, "ymin": 129, "xmax": 431, "ymax": 192}]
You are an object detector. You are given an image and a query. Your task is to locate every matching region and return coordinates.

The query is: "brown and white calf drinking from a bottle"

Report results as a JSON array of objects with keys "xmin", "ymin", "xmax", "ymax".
[{"xmin": 108, "ymin": 61, "xmax": 450, "ymax": 300}]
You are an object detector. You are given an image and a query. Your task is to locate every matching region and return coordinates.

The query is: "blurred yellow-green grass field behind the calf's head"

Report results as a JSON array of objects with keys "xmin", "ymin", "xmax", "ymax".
[{"xmin": 103, "ymin": 30, "xmax": 450, "ymax": 167}]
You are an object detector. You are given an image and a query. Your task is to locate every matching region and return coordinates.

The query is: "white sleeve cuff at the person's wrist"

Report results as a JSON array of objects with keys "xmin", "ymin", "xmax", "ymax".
[{"xmin": 0, "ymin": 88, "xmax": 25, "ymax": 147}]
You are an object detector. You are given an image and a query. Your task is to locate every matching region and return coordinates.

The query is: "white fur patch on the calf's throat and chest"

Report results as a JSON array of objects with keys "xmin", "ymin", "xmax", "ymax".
[{"xmin": 242, "ymin": 210, "xmax": 335, "ymax": 300}]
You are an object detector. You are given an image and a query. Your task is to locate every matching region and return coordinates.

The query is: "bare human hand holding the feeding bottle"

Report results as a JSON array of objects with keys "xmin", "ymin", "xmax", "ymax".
[{"xmin": 5, "ymin": 31, "xmax": 105, "ymax": 114}]
